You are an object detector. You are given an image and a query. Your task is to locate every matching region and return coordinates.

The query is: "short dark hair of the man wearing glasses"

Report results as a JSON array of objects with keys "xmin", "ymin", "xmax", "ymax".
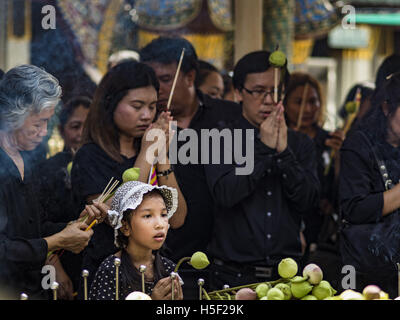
[{"xmin": 233, "ymin": 51, "xmax": 290, "ymax": 90}]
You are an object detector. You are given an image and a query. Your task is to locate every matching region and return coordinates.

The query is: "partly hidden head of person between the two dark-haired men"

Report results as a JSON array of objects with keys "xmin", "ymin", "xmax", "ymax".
[{"xmin": 195, "ymin": 60, "xmax": 224, "ymax": 99}]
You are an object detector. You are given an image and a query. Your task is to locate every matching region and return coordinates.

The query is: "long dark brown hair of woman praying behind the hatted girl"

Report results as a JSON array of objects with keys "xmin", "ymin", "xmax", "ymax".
[{"xmin": 83, "ymin": 61, "xmax": 160, "ymax": 163}]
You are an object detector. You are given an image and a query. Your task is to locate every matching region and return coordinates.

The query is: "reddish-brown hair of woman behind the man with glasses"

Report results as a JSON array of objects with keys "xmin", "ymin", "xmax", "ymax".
[{"xmin": 283, "ymin": 72, "xmax": 325, "ymax": 126}]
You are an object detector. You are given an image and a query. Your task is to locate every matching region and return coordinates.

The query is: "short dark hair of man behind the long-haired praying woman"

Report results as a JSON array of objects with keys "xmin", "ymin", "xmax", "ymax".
[{"xmin": 140, "ymin": 36, "xmax": 198, "ymax": 73}]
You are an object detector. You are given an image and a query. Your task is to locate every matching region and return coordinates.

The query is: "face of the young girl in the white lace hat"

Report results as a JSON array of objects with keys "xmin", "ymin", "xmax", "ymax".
[{"xmin": 125, "ymin": 194, "xmax": 168, "ymax": 250}]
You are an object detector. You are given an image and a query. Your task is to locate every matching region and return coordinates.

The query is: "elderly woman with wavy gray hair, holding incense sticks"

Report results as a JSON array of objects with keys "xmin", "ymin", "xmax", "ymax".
[{"xmin": 0, "ymin": 65, "xmax": 107, "ymax": 299}]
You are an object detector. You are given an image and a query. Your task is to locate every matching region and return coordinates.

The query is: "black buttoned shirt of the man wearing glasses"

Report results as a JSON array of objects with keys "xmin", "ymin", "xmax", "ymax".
[{"xmin": 205, "ymin": 117, "xmax": 319, "ymax": 265}]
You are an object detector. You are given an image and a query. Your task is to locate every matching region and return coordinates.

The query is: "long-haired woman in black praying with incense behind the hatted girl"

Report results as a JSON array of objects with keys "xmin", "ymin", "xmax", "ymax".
[{"xmin": 72, "ymin": 62, "xmax": 186, "ymax": 296}]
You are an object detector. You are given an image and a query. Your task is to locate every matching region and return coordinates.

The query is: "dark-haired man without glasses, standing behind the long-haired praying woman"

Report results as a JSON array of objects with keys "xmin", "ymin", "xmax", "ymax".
[{"xmin": 140, "ymin": 37, "xmax": 240, "ymax": 299}]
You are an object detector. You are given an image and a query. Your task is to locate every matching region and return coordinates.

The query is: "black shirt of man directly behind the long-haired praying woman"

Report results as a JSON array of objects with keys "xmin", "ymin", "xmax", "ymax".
[{"xmin": 165, "ymin": 91, "xmax": 241, "ymax": 262}]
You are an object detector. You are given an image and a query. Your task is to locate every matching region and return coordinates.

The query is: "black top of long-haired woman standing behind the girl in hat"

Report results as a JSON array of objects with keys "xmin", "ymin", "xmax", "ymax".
[{"xmin": 71, "ymin": 143, "xmax": 136, "ymax": 297}]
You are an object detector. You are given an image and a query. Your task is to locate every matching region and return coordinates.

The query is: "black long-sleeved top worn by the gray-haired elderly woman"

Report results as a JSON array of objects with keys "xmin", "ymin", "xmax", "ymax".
[{"xmin": 0, "ymin": 149, "xmax": 66, "ymax": 299}]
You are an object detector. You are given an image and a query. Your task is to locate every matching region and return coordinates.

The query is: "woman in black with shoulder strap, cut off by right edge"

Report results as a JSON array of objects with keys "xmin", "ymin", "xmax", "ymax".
[{"xmin": 339, "ymin": 72, "xmax": 400, "ymax": 298}]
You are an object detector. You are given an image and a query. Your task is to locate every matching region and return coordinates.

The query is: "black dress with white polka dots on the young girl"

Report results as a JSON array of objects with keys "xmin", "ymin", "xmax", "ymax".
[{"xmin": 89, "ymin": 250, "xmax": 175, "ymax": 300}]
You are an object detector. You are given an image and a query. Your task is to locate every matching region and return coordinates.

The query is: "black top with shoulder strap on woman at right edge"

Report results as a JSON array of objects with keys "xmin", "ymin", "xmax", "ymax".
[{"xmin": 339, "ymin": 131, "xmax": 400, "ymax": 224}]
